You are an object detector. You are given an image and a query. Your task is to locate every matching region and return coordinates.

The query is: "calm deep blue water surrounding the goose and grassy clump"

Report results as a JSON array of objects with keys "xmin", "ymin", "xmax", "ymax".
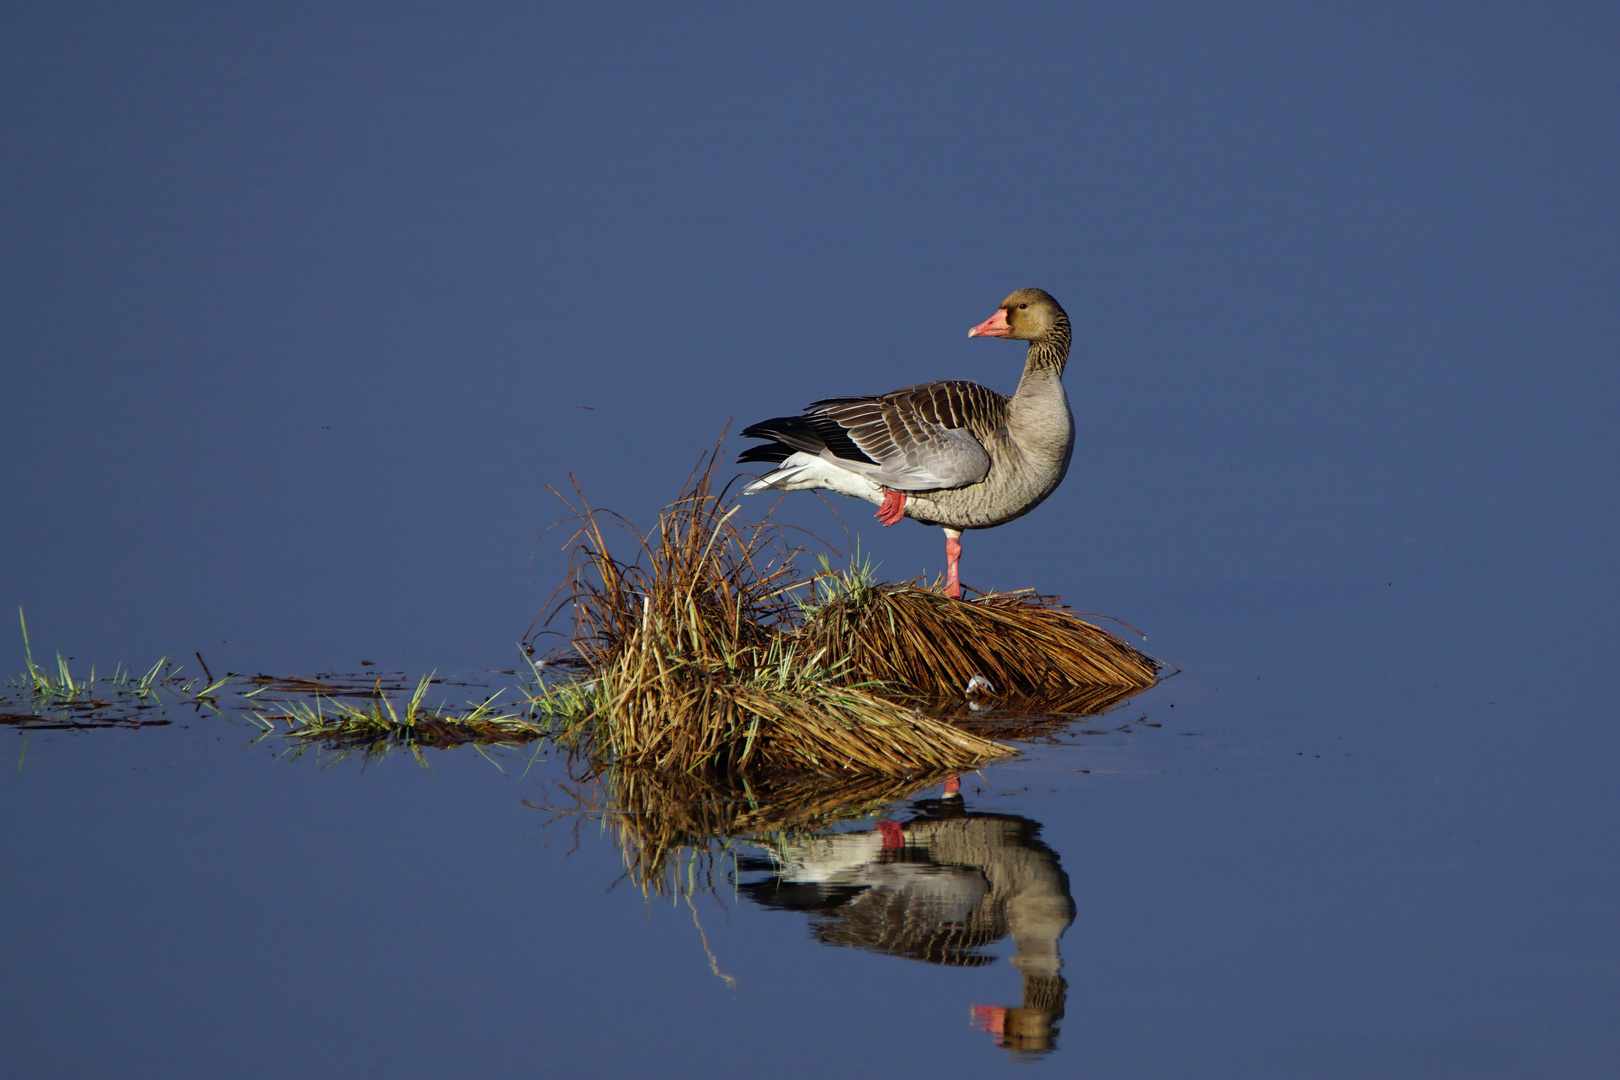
[{"xmin": 0, "ymin": 3, "xmax": 1620, "ymax": 1078}]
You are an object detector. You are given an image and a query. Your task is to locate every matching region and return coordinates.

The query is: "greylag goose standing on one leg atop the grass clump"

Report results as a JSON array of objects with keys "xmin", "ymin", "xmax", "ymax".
[{"xmin": 737, "ymin": 288, "xmax": 1074, "ymax": 599}]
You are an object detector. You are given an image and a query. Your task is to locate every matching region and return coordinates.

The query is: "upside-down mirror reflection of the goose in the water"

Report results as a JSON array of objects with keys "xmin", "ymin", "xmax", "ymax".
[{"xmin": 739, "ymin": 785, "xmax": 1074, "ymax": 1052}]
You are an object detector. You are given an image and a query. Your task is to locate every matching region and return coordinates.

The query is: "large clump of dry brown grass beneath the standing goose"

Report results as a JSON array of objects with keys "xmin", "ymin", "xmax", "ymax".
[{"xmin": 535, "ymin": 447, "xmax": 1158, "ymax": 777}]
